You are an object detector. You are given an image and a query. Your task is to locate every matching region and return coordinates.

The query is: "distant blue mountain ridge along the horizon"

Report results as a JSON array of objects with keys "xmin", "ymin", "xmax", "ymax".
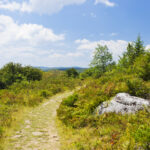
[{"xmin": 35, "ymin": 66, "xmax": 88, "ymax": 72}]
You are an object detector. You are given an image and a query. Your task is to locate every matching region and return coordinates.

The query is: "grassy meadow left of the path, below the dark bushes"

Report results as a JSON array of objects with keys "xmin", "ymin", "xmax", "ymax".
[{"xmin": 0, "ymin": 71, "xmax": 80, "ymax": 149}]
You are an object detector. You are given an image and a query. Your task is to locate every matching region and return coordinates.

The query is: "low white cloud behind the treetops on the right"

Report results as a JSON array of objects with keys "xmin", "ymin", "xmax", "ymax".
[{"xmin": 75, "ymin": 39, "xmax": 128, "ymax": 60}]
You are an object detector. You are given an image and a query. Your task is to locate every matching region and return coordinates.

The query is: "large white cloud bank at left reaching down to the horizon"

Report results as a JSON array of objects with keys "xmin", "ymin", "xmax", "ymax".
[{"xmin": 0, "ymin": 15, "xmax": 88, "ymax": 67}]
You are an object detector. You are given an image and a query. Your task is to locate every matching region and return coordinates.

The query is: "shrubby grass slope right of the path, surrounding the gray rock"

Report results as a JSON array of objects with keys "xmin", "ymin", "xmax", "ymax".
[{"xmin": 57, "ymin": 68, "xmax": 150, "ymax": 150}]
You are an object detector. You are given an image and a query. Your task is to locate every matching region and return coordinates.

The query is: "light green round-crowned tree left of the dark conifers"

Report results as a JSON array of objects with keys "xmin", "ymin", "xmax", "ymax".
[{"xmin": 90, "ymin": 44, "xmax": 112, "ymax": 73}]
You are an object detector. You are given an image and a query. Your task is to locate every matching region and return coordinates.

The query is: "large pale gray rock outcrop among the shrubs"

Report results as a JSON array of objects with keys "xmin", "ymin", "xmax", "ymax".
[{"xmin": 96, "ymin": 93, "xmax": 150, "ymax": 115}]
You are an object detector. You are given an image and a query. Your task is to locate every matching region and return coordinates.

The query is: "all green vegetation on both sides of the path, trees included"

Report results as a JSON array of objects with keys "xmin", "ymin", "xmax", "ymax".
[{"xmin": 0, "ymin": 37, "xmax": 150, "ymax": 150}]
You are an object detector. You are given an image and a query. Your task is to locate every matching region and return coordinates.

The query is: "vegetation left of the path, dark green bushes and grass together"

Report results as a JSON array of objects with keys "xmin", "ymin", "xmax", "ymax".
[{"xmin": 0, "ymin": 63, "xmax": 80, "ymax": 149}]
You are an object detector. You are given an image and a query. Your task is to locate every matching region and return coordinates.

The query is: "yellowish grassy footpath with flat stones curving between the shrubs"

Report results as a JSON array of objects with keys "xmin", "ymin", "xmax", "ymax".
[{"xmin": 2, "ymin": 91, "xmax": 75, "ymax": 150}]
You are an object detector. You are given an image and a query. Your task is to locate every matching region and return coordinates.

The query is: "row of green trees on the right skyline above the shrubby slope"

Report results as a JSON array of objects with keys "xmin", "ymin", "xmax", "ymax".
[{"xmin": 80, "ymin": 36, "xmax": 150, "ymax": 81}]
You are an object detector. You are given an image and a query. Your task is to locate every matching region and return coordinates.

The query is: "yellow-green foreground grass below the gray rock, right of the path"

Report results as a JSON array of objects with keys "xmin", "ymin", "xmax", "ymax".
[{"xmin": 57, "ymin": 111, "xmax": 150, "ymax": 150}]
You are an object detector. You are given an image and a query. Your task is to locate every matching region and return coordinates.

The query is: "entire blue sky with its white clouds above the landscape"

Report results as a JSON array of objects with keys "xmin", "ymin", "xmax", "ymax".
[{"xmin": 0, "ymin": 0, "xmax": 150, "ymax": 67}]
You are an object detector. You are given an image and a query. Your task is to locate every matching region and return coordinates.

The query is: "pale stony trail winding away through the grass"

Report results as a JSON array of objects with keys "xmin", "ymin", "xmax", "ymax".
[{"xmin": 4, "ymin": 92, "xmax": 73, "ymax": 150}]
